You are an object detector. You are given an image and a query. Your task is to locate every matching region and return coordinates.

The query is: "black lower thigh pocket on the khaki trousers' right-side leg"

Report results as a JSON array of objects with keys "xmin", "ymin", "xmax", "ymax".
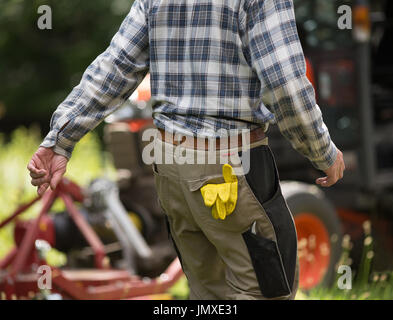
[{"xmin": 243, "ymin": 230, "xmax": 291, "ymax": 298}]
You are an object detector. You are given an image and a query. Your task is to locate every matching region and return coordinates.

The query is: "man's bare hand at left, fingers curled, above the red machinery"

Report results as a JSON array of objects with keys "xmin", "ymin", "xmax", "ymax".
[{"xmin": 27, "ymin": 147, "xmax": 68, "ymax": 196}]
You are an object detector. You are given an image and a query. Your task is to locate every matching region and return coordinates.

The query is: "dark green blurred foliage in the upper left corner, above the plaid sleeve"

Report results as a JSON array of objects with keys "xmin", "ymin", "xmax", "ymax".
[{"xmin": 0, "ymin": 0, "xmax": 133, "ymax": 129}]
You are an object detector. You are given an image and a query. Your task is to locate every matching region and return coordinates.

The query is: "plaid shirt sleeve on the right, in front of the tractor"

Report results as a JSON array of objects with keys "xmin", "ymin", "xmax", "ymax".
[{"xmin": 239, "ymin": 0, "xmax": 337, "ymax": 170}]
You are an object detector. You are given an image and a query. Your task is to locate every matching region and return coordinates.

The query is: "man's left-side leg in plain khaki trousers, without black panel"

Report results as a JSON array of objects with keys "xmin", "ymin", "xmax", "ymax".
[{"xmin": 155, "ymin": 165, "xmax": 228, "ymax": 300}]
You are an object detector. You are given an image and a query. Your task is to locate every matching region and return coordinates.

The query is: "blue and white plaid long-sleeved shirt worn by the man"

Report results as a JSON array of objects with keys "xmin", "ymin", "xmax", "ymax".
[{"xmin": 42, "ymin": 0, "xmax": 337, "ymax": 170}]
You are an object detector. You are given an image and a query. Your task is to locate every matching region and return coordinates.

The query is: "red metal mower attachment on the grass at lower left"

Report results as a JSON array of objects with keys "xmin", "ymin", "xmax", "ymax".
[{"xmin": 0, "ymin": 179, "xmax": 183, "ymax": 300}]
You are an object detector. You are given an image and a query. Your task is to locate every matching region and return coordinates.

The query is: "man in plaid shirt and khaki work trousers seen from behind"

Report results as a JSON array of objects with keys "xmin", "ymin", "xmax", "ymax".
[{"xmin": 28, "ymin": 0, "xmax": 345, "ymax": 299}]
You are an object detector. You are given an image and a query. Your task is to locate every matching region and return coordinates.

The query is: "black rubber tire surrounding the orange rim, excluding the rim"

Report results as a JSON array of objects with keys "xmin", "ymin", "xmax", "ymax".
[{"xmin": 281, "ymin": 181, "xmax": 342, "ymax": 286}]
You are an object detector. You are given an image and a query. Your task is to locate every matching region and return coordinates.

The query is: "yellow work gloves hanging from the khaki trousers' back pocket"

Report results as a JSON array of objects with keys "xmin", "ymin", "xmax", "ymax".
[{"xmin": 201, "ymin": 164, "xmax": 237, "ymax": 220}]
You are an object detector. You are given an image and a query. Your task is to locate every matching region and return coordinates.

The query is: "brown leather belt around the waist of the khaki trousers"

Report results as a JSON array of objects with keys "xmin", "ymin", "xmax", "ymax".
[{"xmin": 158, "ymin": 128, "xmax": 266, "ymax": 151}]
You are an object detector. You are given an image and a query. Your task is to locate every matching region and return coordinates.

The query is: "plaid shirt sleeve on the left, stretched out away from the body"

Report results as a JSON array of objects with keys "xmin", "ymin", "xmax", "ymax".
[{"xmin": 41, "ymin": 0, "xmax": 149, "ymax": 158}]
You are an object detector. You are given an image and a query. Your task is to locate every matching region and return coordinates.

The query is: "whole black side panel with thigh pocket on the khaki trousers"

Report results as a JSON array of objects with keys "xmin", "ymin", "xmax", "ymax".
[{"xmin": 239, "ymin": 147, "xmax": 297, "ymax": 298}]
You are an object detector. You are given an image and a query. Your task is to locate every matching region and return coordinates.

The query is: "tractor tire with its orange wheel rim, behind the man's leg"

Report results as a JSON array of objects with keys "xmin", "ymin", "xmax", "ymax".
[{"xmin": 281, "ymin": 181, "xmax": 342, "ymax": 290}]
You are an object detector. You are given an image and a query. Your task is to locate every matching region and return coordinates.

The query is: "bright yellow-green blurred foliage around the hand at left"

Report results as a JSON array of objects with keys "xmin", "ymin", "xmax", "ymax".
[{"xmin": 0, "ymin": 126, "xmax": 116, "ymax": 264}]
